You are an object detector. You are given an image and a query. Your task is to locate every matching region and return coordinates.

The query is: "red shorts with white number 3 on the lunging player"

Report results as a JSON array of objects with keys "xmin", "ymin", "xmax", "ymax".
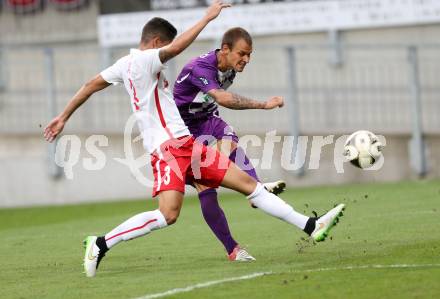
[{"xmin": 151, "ymin": 136, "xmax": 230, "ymax": 197}]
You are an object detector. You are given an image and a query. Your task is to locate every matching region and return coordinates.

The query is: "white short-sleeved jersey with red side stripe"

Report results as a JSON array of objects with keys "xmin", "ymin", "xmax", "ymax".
[{"xmin": 101, "ymin": 49, "xmax": 190, "ymax": 153}]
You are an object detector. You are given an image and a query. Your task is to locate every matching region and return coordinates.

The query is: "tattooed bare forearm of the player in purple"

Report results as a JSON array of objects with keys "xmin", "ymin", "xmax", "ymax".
[{"xmin": 208, "ymin": 89, "xmax": 284, "ymax": 110}]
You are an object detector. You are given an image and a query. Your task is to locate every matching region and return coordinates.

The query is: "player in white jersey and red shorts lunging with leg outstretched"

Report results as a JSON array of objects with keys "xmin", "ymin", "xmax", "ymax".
[{"xmin": 44, "ymin": 1, "xmax": 344, "ymax": 277}]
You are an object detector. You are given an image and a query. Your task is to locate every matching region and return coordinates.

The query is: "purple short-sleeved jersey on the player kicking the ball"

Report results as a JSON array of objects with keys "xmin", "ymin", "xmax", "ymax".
[{"xmin": 174, "ymin": 50, "xmax": 235, "ymax": 130}]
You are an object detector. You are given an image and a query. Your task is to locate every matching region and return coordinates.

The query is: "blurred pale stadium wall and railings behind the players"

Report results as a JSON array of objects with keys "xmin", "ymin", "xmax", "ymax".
[{"xmin": 0, "ymin": 0, "xmax": 440, "ymax": 206}]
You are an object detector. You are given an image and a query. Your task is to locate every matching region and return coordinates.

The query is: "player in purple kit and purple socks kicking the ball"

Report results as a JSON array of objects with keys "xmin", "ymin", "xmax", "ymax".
[{"xmin": 174, "ymin": 27, "xmax": 286, "ymax": 261}]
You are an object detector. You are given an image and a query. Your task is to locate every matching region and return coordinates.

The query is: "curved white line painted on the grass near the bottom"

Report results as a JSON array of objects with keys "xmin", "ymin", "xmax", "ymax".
[{"xmin": 136, "ymin": 264, "xmax": 440, "ymax": 299}]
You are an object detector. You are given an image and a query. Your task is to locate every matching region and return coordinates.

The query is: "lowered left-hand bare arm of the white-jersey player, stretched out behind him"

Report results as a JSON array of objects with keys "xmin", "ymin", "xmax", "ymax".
[{"xmin": 44, "ymin": 75, "xmax": 111, "ymax": 142}]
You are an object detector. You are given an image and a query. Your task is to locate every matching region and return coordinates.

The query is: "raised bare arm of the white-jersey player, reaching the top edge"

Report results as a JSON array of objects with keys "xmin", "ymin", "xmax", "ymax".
[{"xmin": 159, "ymin": 0, "xmax": 231, "ymax": 63}]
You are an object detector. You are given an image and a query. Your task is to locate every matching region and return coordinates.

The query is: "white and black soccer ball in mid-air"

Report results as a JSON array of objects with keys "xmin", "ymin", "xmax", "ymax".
[{"xmin": 344, "ymin": 130, "xmax": 383, "ymax": 169}]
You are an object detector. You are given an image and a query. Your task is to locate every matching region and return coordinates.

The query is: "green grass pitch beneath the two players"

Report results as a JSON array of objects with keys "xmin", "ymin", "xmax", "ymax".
[{"xmin": 0, "ymin": 180, "xmax": 440, "ymax": 299}]
